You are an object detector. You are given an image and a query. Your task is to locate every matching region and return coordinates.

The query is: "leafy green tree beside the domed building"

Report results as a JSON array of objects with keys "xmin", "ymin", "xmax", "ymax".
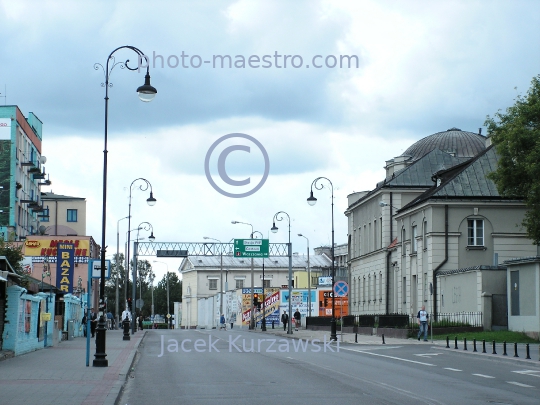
[{"xmin": 485, "ymin": 75, "xmax": 540, "ymax": 244}]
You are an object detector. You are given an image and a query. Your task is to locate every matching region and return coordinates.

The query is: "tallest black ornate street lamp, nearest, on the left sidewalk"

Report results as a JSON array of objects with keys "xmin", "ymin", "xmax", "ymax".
[{"xmin": 92, "ymin": 45, "xmax": 157, "ymax": 367}]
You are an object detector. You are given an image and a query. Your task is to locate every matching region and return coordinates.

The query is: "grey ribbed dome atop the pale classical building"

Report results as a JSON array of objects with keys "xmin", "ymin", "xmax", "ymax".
[{"xmin": 403, "ymin": 128, "xmax": 486, "ymax": 160}]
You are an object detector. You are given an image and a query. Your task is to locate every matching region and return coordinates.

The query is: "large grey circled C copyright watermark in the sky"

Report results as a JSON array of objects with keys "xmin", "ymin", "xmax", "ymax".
[{"xmin": 204, "ymin": 133, "xmax": 270, "ymax": 198}]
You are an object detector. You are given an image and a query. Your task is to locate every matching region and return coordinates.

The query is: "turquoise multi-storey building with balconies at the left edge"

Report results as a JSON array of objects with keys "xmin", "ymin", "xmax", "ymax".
[{"xmin": 0, "ymin": 106, "xmax": 50, "ymax": 240}]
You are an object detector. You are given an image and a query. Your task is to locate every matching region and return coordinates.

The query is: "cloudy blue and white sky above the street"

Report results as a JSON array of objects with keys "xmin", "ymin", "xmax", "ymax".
[{"xmin": 0, "ymin": 0, "xmax": 540, "ymax": 275}]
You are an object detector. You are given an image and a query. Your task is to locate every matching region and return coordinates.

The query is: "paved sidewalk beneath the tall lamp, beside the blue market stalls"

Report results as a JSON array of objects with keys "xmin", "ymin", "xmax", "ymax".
[{"xmin": 0, "ymin": 330, "xmax": 145, "ymax": 405}]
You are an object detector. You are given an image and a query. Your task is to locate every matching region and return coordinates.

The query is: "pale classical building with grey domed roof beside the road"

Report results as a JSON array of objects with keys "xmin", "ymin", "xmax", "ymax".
[{"xmin": 346, "ymin": 128, "xmax": 536, "ymax": 315}]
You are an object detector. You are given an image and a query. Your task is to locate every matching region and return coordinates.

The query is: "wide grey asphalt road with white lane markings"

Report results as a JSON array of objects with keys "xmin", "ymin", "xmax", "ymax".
[{"xmin": 119, "ymin": 329, "xmax": 540, "ymax": 405}]
